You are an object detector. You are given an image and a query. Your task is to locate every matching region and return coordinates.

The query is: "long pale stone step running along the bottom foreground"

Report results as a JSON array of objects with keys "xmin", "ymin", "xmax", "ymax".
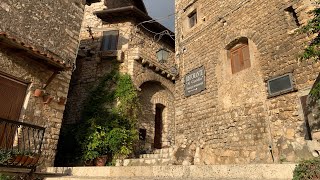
[{"xmin": 46, "ymin": 164, "xmax": 295, "ymax": 180}]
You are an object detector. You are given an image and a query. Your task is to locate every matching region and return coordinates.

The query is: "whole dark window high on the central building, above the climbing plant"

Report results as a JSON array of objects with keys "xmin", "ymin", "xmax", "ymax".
[{"xmin": 101, "ymin": 31, "xmax": 119, "ymax": 51}]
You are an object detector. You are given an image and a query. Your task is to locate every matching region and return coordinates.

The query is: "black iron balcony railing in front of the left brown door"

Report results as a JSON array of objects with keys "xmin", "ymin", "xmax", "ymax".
[{"xmin": 0, "ymin": 118, "xmax": 45, "ymax": 169}]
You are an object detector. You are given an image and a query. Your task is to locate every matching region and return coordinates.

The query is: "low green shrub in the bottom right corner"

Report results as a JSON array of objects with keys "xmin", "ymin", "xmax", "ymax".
[{"xmin": 293, "ymin": 158, "xmax": 320, "ymax": 180}]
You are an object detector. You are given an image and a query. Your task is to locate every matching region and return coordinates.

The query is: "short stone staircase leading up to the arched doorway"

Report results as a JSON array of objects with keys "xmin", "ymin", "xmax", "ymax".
[{"xmin": 117, "ymin": 148, "xmax": 173, "ymax": 166}]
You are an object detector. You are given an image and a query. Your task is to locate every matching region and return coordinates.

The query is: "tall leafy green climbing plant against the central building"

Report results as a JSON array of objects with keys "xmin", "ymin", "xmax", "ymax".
[{"xmin": 76, "ymin": 71, "xmax": 139, "ymax": 161}]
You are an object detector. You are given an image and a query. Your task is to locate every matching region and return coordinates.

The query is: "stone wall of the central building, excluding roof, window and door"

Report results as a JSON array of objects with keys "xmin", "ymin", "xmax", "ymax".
[{"xmin": 64, "ymin": 2, "xmax": 175, "ymax": 150}]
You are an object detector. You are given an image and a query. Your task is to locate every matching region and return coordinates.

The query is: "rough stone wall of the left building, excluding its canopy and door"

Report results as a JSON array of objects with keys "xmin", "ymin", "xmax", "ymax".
[{"xmin": 0, "ymin": 0, "xmax": 84, "ymax": 166}]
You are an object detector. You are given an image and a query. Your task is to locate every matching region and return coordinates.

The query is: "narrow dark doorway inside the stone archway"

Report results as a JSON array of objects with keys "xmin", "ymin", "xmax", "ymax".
[{"xmin": 154, "ymin": 104, "xmax": 165, "ymax": 149}]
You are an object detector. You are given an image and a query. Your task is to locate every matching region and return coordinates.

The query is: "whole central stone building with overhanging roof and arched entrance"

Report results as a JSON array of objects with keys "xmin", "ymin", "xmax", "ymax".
[{"xmin": 64, "ymin": 0, "xmax": 176, "ymax": 151}]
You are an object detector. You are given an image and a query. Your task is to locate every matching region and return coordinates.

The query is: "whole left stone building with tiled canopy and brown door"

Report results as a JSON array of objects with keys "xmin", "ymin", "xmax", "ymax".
[{"xmin": 0, "ymin": 0, "xmax": 84, "ymax": 166}]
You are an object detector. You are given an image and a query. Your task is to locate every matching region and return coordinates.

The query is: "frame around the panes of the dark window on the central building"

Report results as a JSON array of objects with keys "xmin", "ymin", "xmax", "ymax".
[{"xmin": 100, "ymin": 30, "xmax": 120, "ymax": 51}]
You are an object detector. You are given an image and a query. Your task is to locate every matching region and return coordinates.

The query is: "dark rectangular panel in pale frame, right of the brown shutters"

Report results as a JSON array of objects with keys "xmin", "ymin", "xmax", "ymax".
[{"xmin": 268, "ymin": 74, "xmax": 294, "ymax": 96}]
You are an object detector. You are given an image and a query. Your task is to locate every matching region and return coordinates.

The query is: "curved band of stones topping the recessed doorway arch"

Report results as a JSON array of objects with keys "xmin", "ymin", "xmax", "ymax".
[{"xmin": 134, "ymin": 72, "xmax": 174, "ymax": 93}]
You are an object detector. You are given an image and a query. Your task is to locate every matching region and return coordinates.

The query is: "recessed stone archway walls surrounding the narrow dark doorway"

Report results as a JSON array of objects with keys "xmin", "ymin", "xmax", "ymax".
[{"xmin": 139, "ymin": 78, "xmax": 175, "ymax": 151}]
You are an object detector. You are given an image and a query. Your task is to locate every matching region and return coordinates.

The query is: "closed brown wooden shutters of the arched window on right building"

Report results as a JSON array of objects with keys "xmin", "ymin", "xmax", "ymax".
[{"xmin": 229, "ymin": 39, "xmax": 251, "ymax": 74}]
